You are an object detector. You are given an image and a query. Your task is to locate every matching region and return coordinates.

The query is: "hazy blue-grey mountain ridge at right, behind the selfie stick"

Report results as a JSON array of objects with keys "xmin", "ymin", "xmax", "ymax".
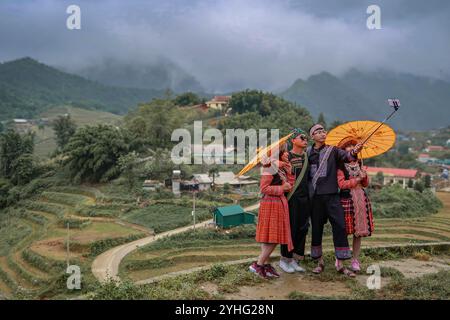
[{"xmin": 280, "ymin": 69, "xmax": 450, "ymax": 130}]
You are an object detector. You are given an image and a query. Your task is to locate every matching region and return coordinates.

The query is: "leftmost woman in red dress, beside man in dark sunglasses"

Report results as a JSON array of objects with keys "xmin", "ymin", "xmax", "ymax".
[{"xmin": 250, "ymin": 144, "xmax": 295, "ymax": 278}]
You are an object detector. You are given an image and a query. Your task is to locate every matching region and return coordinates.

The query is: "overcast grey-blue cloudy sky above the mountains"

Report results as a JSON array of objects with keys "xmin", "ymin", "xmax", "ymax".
[{"xmin": 0, "ymin": 0, "xmax": 450, "ymax": 91}]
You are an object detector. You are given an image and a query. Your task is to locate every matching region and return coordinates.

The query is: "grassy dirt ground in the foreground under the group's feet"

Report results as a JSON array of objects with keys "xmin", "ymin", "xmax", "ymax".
[{"xmin": 96, "ymin": 244, "xmax": 450, "ymax": 301}]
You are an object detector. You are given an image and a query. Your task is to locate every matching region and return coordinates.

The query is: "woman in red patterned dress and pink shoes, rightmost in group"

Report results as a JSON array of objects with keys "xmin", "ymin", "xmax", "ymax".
[{"xmin": 337, "ymin": 140, "xmax": 374, "ymax": 272}]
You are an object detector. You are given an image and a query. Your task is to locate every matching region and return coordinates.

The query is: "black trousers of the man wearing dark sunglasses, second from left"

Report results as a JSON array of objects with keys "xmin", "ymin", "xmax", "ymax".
[{"xmin": 280, "ymin": 194, "xmax": 311, "ymax": 258}]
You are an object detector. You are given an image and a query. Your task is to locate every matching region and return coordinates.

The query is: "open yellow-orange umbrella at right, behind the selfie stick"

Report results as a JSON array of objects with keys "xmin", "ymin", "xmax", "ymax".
[{"xmin": 325, "ymin": 121, "xmax": 396, "ymax": 159}]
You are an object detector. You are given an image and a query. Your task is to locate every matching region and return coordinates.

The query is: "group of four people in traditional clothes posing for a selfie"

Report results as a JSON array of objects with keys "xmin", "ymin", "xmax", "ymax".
[{"xmin": 250, "ymin": 124, "xmax": 374, "ymax": 278}]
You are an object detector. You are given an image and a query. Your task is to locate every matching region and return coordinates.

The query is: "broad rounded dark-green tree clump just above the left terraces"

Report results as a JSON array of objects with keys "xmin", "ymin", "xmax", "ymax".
[{"xmin": 64, "ymin": 125, "xmax": 141, "ymax": 182}]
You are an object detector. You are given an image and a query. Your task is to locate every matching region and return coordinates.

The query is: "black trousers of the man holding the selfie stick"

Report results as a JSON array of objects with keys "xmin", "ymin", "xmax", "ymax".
[{"xmin": 311, "ymin": 194, "xmax": 351, "ymax": 260}]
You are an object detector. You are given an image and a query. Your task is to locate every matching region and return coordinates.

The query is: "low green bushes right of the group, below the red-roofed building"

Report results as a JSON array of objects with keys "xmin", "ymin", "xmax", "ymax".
[{"xmin": 370, "ymin": 185, "xmax": 442, "ymax": 218}]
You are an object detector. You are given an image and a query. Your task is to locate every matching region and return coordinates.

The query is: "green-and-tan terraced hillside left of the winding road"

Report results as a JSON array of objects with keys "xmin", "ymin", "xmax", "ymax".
[{"xmin": 0, "ymin": 185, "xmax": 232, "ymax": 299}]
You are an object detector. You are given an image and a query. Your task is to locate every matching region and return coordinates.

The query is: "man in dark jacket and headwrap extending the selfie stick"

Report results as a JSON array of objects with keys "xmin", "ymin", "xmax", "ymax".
[{"xmin": 307, "ymin": 124, "xmax": 362, "ymax": 276}]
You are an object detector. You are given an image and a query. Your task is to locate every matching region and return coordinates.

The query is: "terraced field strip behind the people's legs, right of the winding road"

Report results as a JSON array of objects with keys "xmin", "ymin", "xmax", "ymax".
[{"xmin": 120, "ymin": 193, "xmax": 450, "ymax": 281}]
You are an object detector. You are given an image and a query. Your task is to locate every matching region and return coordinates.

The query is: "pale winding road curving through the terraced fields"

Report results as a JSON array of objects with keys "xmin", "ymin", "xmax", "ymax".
[{"xmin": 91, "ymin": 202, "xmax": 259, "ymax": 281}]
